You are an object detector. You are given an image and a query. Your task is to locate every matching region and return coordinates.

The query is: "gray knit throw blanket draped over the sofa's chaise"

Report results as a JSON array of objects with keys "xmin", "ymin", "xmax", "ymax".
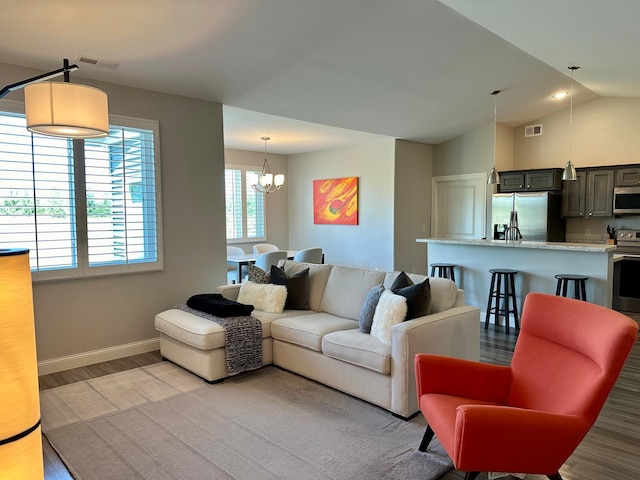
[{"xmin": 176, "ymin": 305, "xmax": 262, "ymax": 375}]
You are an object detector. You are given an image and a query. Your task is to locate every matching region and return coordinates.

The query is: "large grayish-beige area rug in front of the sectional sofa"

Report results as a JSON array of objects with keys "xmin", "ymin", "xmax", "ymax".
[{"xmin": 41, "ymin": 362, "xmax": 452, "ymax": 480}]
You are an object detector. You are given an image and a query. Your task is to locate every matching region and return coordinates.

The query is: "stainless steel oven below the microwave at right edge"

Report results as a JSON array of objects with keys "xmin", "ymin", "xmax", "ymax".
[{"xmin": 613, "ymin": 230, "xmax": 640, "ymax": 312}]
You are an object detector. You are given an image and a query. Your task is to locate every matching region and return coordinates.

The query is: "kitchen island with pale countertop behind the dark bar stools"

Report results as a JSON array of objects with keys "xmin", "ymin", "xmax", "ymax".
[{"xmin": 416, "ymin": 238, "xmax": 616, "ymax": 319}]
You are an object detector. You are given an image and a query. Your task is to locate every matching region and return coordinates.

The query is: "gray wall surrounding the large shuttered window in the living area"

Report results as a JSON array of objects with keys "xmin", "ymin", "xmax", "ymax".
[{"xmin": 0, "ymin": 65, "xmax": 226, "ymax": 361}]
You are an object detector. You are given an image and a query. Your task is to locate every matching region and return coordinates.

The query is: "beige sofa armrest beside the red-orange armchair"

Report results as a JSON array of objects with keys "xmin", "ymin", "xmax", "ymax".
[{"xmin": 391, "ymin": 305, "xmax": 480, "ymax": 417}]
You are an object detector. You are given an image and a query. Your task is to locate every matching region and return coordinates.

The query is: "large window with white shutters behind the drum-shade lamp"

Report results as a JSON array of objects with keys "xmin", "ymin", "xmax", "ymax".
[{"xmin": 0, "ymin": 104, "xmax": 162, "ymax": 280}]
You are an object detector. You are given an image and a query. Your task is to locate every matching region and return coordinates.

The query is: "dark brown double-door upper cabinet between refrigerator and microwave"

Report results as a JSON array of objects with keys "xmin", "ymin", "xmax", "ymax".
[{"xmin": 562, "ymin": 169, "xmax": 614, "ymax": 218}]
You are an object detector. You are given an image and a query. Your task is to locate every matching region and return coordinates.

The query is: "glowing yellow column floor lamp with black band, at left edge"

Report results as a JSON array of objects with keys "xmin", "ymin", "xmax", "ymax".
[{"xmin": 0, "ymin": 249, "xmax": 44, "ymax": 480}]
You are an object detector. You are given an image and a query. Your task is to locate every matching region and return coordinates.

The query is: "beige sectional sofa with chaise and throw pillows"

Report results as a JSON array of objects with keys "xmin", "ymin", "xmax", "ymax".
[{"xmin": 155, "ymin": 261, "xmax": 480, "ymax": 418}]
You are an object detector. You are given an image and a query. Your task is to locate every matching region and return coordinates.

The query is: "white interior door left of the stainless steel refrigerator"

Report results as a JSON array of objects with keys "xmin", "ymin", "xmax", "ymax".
[{"xmin": 431, "ymin": 173, "xmax": 487, "ymax": 239}]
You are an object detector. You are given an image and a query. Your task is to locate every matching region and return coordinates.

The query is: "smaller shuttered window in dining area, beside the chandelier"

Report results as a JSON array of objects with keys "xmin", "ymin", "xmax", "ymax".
[{"xmin": 225, "ymin": 165, "xmax": 265, "ymax": 242}]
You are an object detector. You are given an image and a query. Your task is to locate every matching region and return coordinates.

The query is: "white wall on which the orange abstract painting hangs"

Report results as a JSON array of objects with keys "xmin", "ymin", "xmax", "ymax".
[{"xmin": 288, "ymin": 139, "xmax": 395, "ymax": 270}]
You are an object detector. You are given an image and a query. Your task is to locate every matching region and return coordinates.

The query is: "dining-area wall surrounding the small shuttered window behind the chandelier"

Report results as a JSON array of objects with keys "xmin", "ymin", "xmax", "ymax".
[{"xmin": 224, "ymin": 148, "xmax": 289, "ymax": 253}]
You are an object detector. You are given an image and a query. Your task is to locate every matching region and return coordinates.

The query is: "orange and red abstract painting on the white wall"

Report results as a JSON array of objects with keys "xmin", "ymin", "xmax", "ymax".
[{"xmin": 313, "ymin": 177, "xmax": 358, "ymax": 225}]
